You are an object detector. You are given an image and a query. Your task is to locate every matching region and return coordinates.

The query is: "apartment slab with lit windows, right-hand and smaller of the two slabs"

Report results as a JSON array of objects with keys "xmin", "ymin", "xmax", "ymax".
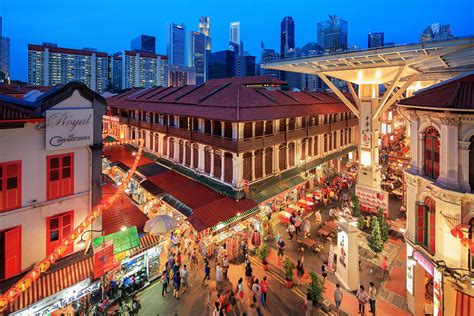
[{"xmin": 115, "ymin": 50, "xmax": 168, "ymax": 89}]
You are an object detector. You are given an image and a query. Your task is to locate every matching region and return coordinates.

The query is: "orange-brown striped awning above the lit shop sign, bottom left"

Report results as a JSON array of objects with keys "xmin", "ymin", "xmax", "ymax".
[{"xmin": 7, "ymin": 254, "xmax": 94, "ymax": 315}]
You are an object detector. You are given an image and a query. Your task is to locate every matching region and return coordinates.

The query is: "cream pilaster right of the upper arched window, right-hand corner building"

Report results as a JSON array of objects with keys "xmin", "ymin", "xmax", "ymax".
[{"xmin": 437, "ymin": 118, "xmax": 459, "ymax": 190}]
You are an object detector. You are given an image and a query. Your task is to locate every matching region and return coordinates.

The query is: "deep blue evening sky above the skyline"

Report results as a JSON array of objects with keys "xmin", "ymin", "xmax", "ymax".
[{"xmin": 0, "ymin": 0, "xmax": 474, "ymax": 81}]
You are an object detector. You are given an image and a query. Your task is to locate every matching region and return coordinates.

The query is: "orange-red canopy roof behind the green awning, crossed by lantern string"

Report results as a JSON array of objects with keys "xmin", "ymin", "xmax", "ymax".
[{"xmin": 102, "ymin": 182, "xmax": 148, "ymax": 235}]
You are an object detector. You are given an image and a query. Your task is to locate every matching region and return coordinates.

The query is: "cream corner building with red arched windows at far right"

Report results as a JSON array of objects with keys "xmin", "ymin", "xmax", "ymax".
[{"xmin": 399, "ymin": 75, "xmax": 474, "ymax": 315}]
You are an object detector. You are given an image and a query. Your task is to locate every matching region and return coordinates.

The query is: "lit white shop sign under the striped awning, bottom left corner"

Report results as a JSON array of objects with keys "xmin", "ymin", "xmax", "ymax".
[{"xmin": 11, "ymin": 279, "xmax": 100, "ymax": 316}]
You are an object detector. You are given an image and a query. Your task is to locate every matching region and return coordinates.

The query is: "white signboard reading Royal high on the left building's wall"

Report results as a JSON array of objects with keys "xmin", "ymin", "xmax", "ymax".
[{"xmin": 46, "ymin": 109, "xmax": 94, "ymax": 150}]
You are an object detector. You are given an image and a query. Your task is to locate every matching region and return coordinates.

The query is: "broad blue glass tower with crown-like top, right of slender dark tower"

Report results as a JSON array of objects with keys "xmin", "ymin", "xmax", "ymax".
[{"xmin": 318, "ymin": 15, "xmax": 348, "ymax": 52}]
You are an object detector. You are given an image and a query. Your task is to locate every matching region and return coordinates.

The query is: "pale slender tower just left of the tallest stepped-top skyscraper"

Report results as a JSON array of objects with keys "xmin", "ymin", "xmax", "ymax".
[{"xmin": 188, "ymin": 31, "xmax": 207, "ymax": 84}]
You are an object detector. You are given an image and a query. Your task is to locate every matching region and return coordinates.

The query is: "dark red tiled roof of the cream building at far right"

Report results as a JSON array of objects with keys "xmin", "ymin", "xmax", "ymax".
[{"xmin": 399, "ymin": 73, "xmax": 474, "ymax": 110}]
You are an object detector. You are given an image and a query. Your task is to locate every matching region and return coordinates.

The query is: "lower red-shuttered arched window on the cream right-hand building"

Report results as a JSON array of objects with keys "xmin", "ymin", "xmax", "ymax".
[{"xmin": 416, "ymin": 197, "xmax": 436, "ymax": 254}]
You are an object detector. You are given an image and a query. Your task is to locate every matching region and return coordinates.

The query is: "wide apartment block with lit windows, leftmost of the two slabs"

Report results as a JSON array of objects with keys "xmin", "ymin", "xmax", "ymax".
[{"xmin": 28, "ymin": 43, "xmax": 108, "ymax": 93}]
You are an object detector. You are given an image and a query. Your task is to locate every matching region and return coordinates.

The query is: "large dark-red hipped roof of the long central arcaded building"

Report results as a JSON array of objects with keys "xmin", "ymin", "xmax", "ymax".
[{"xmin": 107, "ymin": 77, "xmax": 349, "ymax": 122}]
